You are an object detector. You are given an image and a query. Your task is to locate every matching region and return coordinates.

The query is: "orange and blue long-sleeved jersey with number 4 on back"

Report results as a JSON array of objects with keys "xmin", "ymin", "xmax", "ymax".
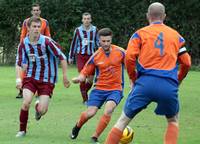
[{"xmin": 126, "ymin": 22, "xmax": 191, "ymax": 81}]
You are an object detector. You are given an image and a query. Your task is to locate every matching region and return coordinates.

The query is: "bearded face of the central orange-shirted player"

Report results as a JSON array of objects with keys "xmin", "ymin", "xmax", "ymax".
[{"xmin": 99, "ymin": 36, "xmax": 112, "ymax": 52}]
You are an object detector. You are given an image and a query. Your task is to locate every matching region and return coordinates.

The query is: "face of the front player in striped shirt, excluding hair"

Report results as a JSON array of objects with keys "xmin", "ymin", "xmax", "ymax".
[{"xmin": 29, "ymin": 22, "xmax": 41, "ymax": 37}]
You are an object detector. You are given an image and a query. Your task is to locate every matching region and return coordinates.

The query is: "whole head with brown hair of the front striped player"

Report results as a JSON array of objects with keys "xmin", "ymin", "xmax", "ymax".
[{"xmin": 27, "ymin": 16, "xmax": 41, "ymax": 36}]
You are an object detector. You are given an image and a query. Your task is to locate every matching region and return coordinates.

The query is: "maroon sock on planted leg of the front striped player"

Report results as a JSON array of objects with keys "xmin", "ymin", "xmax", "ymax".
[{"xmin": 19, "ymin": 109, "xmax": 28, "ymax": 132}]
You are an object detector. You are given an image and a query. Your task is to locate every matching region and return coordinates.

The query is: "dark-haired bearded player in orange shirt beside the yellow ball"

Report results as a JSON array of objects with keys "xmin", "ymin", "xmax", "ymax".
[{"xmin": 71, "ymin": 28, "xmax": 125, "ymax": 143}]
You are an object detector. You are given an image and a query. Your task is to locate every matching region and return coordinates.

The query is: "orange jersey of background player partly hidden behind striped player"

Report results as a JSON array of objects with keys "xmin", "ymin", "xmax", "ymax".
[{"xmin": 20, "ymin": 18, "xmax": 51, "ymax": 42}]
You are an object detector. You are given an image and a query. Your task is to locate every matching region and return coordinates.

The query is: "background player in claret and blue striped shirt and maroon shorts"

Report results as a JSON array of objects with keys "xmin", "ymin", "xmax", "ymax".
[{"xmin": 68, "ymin": 12, "xmax": 99, "ymax": 103}]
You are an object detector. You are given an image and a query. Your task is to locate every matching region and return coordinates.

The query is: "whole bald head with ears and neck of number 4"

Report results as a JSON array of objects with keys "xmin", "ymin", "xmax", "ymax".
[{"xmin": 147, "ymin": 2, "xmax": 166, "ymax": 23}]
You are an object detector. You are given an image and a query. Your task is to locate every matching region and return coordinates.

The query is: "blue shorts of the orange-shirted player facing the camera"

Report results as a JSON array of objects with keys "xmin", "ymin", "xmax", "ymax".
[{"xmin": 87, "ymin": 89, "xmax": 123, "ymax": 108}]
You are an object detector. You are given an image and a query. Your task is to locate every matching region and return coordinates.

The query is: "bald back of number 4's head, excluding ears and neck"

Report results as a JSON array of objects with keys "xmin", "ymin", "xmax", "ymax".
[{"xmin": 147, "ymin": 2, "xmax": 165, "ymax": 19}]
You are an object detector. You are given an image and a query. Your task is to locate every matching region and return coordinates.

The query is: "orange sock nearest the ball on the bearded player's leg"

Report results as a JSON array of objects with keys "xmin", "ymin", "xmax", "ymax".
[{"xmin": 93, "ymin": 114, "xmax": 111, "ymax": 138}]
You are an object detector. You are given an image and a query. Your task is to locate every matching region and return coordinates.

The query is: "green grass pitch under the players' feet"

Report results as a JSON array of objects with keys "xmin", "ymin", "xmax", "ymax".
[{"xmin": 0, "ymin": 66, "xmax": 200, "ymax": 144}]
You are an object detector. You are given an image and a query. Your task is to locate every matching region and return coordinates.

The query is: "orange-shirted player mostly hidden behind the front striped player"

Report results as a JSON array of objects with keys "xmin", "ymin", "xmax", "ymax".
[{"xmin": 16, "ymin": 3, "xmax": 51, "ymax": 98}]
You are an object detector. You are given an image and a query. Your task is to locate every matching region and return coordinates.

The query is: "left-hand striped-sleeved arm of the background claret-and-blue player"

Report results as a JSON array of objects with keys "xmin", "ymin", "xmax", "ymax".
[{"xmin": 68, "ymin": 29, "xmax": 78, "ymax": 64}]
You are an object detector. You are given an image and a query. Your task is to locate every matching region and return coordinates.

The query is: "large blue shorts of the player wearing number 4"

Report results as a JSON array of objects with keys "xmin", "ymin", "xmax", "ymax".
[{"xmin": 124, "ymin": 76, "xmax": 179, "ymax": 118}]
